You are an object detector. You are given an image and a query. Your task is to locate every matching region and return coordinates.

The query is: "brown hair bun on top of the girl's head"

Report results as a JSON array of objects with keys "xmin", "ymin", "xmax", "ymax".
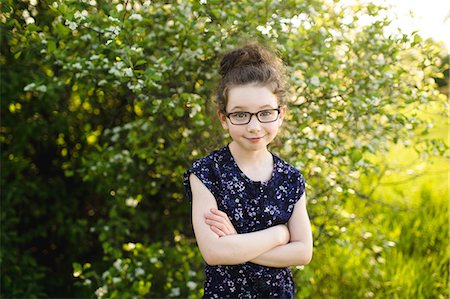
[{"xmin": 219, "ymin": 44, "xmax": 274, "ymax": 77}]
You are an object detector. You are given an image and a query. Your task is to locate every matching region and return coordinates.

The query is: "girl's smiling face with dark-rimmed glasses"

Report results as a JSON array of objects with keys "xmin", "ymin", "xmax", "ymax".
[{"xmin": 219, "ymin": 84, "xmax": 286, "ymax": 151}]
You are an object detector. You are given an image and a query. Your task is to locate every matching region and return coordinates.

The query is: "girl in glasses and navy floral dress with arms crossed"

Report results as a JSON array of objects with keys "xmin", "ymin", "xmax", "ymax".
[{"xmin": 184, "ymin": 44, "xmax": 312, "ymax": 298}]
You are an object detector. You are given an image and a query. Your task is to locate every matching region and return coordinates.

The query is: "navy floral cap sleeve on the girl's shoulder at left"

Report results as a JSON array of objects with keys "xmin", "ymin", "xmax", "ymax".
[{"xmin": 183, "ymin": 157, "xmax": 219, "ymax": 202}]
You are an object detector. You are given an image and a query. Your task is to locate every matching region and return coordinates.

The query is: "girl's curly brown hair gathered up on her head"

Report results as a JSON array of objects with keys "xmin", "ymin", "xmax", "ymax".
[{"xmin": 216, "ymin": 43, "xmax": 286, "ymax": 113}]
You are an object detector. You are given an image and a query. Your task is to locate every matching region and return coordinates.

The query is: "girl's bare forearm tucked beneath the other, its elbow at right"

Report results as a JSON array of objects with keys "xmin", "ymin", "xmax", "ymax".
[{"xmin": 250, "ymin": 241, "xmax": 312, "ymax": 268}]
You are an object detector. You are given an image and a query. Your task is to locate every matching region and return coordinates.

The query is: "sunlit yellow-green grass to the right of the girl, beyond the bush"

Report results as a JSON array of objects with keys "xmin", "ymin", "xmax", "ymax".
[{"xmin": 294, "ymin": 99, "xmax": 450, "ymax": 298}]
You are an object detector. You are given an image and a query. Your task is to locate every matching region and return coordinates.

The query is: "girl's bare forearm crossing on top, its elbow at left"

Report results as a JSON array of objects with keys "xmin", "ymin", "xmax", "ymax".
[{"xmin": 202, "ymin": 226, "xmax": 287, "ymax": 265}]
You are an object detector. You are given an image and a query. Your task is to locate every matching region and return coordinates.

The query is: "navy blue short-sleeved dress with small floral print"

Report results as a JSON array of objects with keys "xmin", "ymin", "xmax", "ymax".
[{"xmin": 184, "ymin": 146, "xmax": 305, "ymax": 298}]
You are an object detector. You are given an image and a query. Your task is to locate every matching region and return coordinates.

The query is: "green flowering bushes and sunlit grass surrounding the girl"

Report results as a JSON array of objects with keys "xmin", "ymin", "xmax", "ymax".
[{"xmin": 0, "ymin": 0, "xmax": 449, "ymax": 298}]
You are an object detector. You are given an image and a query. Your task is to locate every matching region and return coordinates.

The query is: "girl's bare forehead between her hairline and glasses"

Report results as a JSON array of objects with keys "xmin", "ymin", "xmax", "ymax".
[{"xmin": 226, "ymin": 85, "xmax": 278, "ymax": 111}]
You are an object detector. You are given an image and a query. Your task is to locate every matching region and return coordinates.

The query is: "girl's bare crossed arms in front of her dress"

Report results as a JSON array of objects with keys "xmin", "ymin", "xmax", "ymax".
[{"xmin": 189, "ymin": 174, "xmax": 312, "ymax": 267}]
